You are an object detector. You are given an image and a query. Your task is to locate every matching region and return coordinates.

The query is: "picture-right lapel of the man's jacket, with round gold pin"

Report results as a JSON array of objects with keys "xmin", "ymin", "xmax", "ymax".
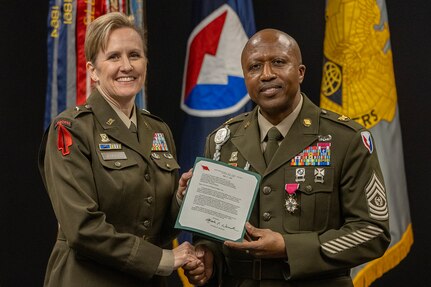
[{"xmin": 265, "ymin": 95, "xmax": 320, "ymax": 175}]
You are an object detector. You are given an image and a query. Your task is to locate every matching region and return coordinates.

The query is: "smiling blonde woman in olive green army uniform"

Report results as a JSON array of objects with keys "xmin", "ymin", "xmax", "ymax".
[{"xmin": 39, "ymin": 13, "xmax": 194, "ymax": 287}]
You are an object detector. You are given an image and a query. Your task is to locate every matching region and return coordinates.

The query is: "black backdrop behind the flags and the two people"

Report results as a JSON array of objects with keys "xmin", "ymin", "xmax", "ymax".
[{"xmin": 0, "ymin": 0, "xmax": 431, "ymax": 287}]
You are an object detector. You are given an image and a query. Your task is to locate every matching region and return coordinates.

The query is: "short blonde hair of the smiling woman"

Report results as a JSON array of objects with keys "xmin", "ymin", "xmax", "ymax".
[{"xmin": 84, "ymin": 12, "xmax": 147, "ymax": 64}]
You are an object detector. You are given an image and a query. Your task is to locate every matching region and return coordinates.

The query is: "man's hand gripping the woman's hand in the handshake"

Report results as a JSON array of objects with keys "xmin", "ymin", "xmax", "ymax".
[{"xmin": 183, "ymin": 245, "xmax": 214, "ymax": 286}]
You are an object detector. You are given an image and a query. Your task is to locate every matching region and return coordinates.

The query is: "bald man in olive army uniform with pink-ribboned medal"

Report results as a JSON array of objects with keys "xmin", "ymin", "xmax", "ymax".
[{"xmin": 184, "ymin": 29, "xmax": 390, "ymax": 287}]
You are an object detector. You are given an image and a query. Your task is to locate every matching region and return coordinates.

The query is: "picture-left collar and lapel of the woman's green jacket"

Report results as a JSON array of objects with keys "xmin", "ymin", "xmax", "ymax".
[{"xmin": 87, "ymin": 89, "xmax": 148, "ymax": 158}]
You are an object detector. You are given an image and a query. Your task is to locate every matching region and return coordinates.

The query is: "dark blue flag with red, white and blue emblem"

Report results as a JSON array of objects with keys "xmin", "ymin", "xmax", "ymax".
[{"xmin": 180, "ymin": 0, "xmax": 256, "ymax": 171}]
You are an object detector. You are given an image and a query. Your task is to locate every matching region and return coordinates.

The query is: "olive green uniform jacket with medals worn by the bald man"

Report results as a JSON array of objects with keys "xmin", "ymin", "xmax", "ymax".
[{"xmin": 197, "ymin": 95, "xmax": 390, "ymax": 287}]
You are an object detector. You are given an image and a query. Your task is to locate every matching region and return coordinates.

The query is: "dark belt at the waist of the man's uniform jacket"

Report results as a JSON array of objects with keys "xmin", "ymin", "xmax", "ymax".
[{"xmin": 226, "ymin": 257, "xmax": 289, "ymax": 280}]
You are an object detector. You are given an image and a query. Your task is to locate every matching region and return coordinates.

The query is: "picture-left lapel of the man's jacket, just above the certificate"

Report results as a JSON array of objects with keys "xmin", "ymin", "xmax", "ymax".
[{"xmin": 231, "ymin": 107, "xmax": 266, "ymax": 174}]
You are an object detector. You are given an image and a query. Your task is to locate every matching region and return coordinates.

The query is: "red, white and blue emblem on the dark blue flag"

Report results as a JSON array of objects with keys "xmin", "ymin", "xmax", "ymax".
[{"xmin": 181, "ymin": 4, "xmax": 250, "ymax": 117}]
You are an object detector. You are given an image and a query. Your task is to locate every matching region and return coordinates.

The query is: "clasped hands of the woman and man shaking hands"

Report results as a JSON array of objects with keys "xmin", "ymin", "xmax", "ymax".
[{"xmin": 172, "ymin": 242, "xmax": 214, "ymax": 286}]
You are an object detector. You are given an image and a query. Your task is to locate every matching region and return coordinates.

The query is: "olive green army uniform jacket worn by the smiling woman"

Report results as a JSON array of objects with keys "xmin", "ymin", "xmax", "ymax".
[{"xmin": 39, "ymin": 90, "xmax": 179, "ymax": 287}]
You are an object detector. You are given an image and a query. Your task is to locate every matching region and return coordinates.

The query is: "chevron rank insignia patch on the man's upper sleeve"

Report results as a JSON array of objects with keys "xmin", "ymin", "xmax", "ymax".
[{"xmin": 365, "ymin": 173, "xmax": 389, "ymax": 220}]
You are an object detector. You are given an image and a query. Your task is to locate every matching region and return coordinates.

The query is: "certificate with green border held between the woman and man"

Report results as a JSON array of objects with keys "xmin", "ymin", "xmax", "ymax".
[{"xmin": 175, "ymin": 157, "xmax": 260, "ymax": 241}]
